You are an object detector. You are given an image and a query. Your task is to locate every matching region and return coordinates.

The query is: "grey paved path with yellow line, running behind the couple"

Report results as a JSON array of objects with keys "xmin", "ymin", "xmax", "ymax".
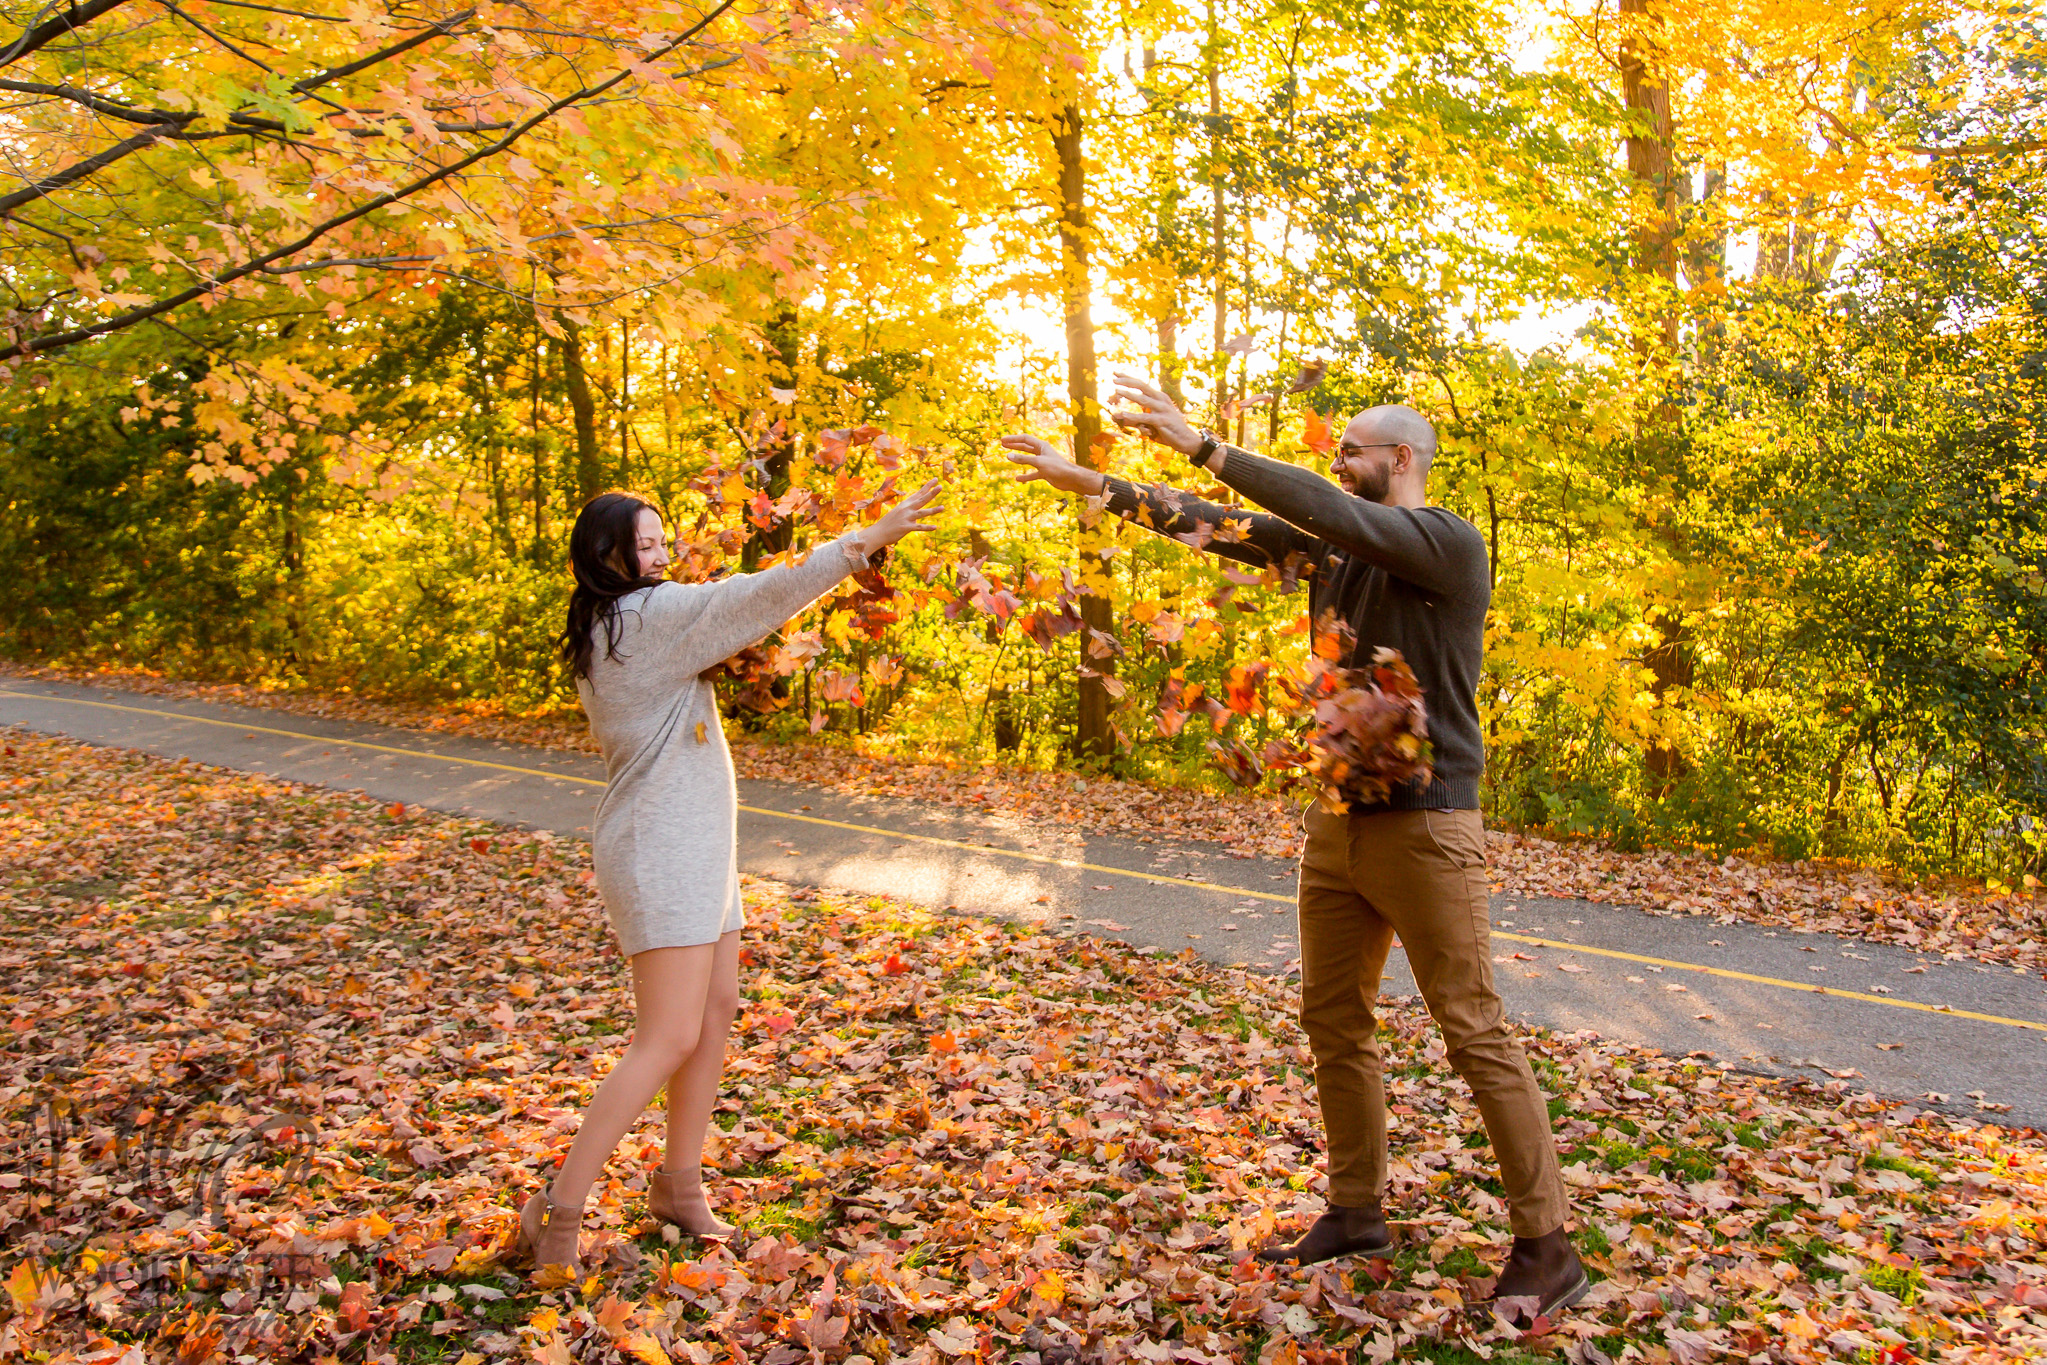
[{"xmin": 0, "ymin": 679, "xmax": 2047, "ymax": 1128}]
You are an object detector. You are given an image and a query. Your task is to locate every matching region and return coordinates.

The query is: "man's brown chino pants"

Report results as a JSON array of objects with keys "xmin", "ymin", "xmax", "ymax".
[{"xmin": 1300, "ymin": 806, "xmax": 1566, "ymax": 1236}]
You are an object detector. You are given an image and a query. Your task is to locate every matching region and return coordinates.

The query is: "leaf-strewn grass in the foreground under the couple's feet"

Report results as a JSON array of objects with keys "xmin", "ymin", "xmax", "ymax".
[{"xmin": 0, "ymin": 731, "xmax": 2047, "ymax": 1365}]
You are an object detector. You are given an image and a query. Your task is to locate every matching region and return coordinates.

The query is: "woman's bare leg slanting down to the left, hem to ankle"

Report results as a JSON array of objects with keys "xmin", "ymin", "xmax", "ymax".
[{"xmin": 553, "ymin": 933, "xmax": 716, "ymax": 1207}]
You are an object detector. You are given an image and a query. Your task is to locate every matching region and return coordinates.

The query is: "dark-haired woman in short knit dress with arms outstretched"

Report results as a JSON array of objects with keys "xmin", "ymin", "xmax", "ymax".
[{"xmin": 520, "ymin": 481, "xmax": 942, "ymax": 1273}]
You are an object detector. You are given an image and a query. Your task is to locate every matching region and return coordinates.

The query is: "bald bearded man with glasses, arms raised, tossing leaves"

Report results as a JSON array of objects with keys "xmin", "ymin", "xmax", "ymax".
[{"xmin": 1003, "ymin": 372, "xmax": 1588, "ymax": 1322}]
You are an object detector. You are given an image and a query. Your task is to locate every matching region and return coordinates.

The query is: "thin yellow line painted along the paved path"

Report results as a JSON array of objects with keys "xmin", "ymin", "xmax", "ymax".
[{"xmin": 12, "ymin": 692, "xmax": 2047, "ymax": 1033}]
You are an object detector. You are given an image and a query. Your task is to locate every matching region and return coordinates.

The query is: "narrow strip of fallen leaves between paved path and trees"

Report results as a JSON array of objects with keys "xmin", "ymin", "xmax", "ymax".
[{"xmin": 0, "ymin": 661, "xmax": 2047, "ymax": 976}]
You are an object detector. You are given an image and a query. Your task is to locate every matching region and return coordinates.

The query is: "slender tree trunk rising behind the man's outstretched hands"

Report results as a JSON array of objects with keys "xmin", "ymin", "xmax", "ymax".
[{"xmin": 1052, "ymin": 104, "xmax": 1116, "ymax": 761}]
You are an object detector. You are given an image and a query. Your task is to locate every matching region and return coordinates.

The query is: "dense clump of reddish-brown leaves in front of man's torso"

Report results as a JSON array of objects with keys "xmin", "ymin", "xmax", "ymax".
[{"xmin": 1210, "ymin": 612, "xmax": 1435, "ymax": 814}]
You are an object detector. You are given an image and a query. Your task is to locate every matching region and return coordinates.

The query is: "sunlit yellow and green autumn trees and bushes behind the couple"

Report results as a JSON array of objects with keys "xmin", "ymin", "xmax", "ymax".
[{"xmin": 0, "ymin": 0, "xmax": 2047, "ymax": 880}]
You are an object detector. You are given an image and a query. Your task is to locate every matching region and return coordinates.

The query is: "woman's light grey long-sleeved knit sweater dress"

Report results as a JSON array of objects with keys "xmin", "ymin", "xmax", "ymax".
[{"xmin": 575, "ymin": 534, "xmax": 868, "ymax": 958}]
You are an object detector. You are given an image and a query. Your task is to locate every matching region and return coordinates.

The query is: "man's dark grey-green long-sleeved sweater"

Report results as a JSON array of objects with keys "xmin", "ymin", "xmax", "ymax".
[{"xmin": 1103, "ymin": 446, "xmax": 1492, "ymax": 812}]
